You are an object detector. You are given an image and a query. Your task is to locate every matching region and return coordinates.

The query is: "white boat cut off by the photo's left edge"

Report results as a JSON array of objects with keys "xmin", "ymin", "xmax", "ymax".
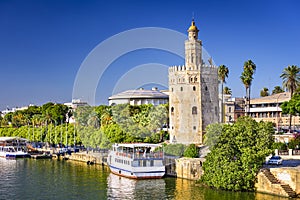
[{"xmin": 0, "ymin": 137, "xmax": 30, "ymax": 159}]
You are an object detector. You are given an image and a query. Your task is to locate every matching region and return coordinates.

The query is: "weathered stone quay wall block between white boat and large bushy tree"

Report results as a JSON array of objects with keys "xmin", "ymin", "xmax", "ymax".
[{"xmin": 176, "ymin": 158, "xmax": 204, "ymax": 180}]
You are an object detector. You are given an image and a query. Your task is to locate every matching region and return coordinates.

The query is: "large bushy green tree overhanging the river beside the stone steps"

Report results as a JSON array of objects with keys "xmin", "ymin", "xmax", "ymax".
[{"xmin": 201, "ymin": 117, "xmax": 274, "ymax": 191}]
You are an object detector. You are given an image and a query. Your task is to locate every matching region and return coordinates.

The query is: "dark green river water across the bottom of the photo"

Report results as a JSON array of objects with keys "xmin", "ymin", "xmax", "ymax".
[{"xmin": 0, "ymin": 158, "xmax": 286, "ymax": 200}]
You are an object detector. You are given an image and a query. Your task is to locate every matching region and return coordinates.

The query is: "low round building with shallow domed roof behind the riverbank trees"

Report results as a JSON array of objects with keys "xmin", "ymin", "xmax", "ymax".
[{"xmin": 108, "ymin": 87, "xmax": 169, "ymax": 106}]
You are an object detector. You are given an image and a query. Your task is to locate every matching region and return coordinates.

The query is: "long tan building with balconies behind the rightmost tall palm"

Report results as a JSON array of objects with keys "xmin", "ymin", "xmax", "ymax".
[{"xmin": 250, "ymin": 92, "xmax": 300, "ymax": 130}]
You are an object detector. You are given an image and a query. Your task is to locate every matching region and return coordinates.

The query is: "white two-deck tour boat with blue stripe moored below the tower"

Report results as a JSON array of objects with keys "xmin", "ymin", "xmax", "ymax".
[{"xmin": 107, "ymin": 143, "xmax": 165, "ymax": 179}]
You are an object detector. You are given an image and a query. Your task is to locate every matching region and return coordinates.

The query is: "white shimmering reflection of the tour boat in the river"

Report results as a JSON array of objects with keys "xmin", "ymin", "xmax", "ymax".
[{"xmin": 107, "ymin": 173, "xmax": 166, "ymax": 199}]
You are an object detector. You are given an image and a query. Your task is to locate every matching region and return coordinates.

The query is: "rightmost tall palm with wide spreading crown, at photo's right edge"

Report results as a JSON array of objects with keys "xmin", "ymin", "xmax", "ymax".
[{"xmin": 280, "ymin": 65, "xmax": 300, "ymax": 131}]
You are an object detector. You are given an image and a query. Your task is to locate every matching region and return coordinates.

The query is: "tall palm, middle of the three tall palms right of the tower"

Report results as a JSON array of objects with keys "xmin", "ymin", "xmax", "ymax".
[{"xmin": 240, "ymin": 60, "xmax": 256, "ymax": 114}]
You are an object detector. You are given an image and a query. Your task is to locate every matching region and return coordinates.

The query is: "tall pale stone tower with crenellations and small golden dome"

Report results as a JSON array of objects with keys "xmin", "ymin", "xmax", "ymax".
[{"xmin": 169, "ymin": 20, "xmax": 219, "ymax": 144}]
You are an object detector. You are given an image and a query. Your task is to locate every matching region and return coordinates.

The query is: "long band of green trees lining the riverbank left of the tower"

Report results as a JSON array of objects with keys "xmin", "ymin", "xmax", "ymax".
[{"xmin": 0, "ymin": 103, "xmax": 168, "ymax": 148}]
